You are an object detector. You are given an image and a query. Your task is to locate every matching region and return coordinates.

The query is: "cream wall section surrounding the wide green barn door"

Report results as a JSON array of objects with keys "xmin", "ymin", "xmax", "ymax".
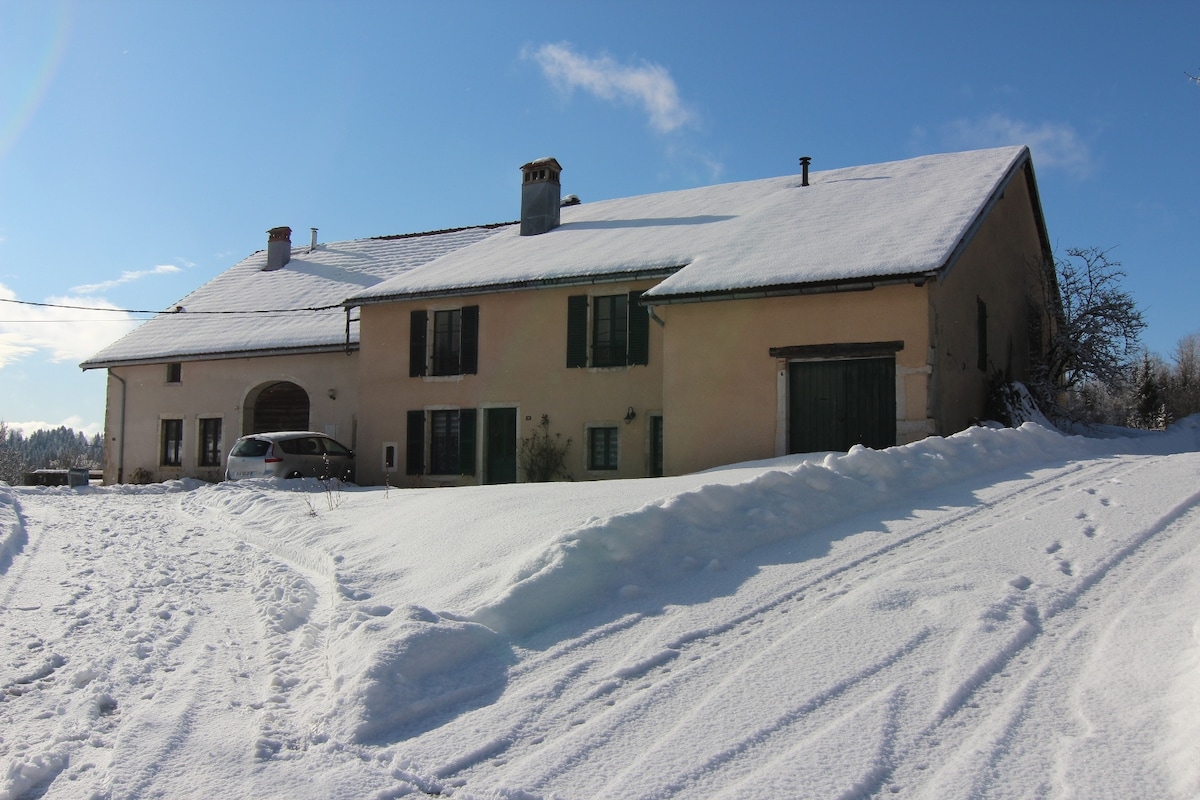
[{"xmin": 655, "ymin": 285, "xmax": 931, "ymax": 475}]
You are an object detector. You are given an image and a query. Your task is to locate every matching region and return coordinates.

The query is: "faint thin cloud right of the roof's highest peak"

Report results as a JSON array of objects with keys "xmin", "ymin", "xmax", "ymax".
[{"xmin": 946, "ymin": 114, "xmax": 1092, "ymax": 178}]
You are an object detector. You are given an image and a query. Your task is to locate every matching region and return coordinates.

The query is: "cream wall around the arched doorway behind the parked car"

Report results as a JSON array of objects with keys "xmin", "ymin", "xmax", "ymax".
[{"xmin": 104, "ymin": 353, "xmax": 358, "ymax": 483}]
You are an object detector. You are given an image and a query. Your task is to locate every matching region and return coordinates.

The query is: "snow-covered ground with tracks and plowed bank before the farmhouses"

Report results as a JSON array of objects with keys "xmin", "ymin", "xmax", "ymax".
[{"xmin": 0, "ymin": 419, "xmax": 1200, "ymax": 800}]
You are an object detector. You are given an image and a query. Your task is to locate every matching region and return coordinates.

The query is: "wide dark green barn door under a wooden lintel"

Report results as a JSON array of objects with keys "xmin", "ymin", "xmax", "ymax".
[{"xmin": 787, "ymin": 357, "xmax": 896, "ymax": 453}]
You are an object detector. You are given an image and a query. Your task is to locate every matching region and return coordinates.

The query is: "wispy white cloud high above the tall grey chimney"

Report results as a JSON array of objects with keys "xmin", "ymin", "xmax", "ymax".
[{"xmin": 523, "ymin": 43, "xmax": 694, "ymax": 133}]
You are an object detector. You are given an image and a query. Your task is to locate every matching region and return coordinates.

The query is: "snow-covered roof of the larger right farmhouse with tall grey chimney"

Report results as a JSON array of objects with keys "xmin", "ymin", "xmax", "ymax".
[{"xmin": 348, "ymin": 146, "xmax": 1028, "ymax": 303}]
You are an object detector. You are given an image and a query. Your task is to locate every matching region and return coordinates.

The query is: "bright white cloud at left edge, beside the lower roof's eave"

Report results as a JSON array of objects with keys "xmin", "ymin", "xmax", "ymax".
[{"xmin": 0, "ymin": 283, "xmax": 137, "ymax": 368}]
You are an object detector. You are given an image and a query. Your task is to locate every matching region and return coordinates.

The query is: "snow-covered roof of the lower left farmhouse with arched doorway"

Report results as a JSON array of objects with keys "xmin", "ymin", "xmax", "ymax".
[{"xmin": 80, "ymin": 225, "xmax": 503, "ymax": 369}]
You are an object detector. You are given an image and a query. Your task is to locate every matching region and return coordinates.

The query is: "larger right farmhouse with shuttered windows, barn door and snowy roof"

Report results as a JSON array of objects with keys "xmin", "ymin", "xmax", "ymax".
[{"xmin": 348, "ymin": 148, "xmax": 1051, "ymax": 485}]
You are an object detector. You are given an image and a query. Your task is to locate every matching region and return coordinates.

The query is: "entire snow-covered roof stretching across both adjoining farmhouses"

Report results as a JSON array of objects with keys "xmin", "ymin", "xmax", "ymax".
[{"xmin": 80, "ymin": 146, "xmax": 1044, "ymax": 369}]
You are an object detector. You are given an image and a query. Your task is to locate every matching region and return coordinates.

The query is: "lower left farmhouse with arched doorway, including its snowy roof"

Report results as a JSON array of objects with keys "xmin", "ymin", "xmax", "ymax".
[{"xmin": 80, "ymin": 225, "xmax": 511, "ymax": 483}]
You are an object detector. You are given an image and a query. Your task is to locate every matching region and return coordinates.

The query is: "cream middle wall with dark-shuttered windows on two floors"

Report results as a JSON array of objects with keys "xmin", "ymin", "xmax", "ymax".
[{"xmin": 358, "ymin": 281, "xmax": 662, "ymax": 486}]
